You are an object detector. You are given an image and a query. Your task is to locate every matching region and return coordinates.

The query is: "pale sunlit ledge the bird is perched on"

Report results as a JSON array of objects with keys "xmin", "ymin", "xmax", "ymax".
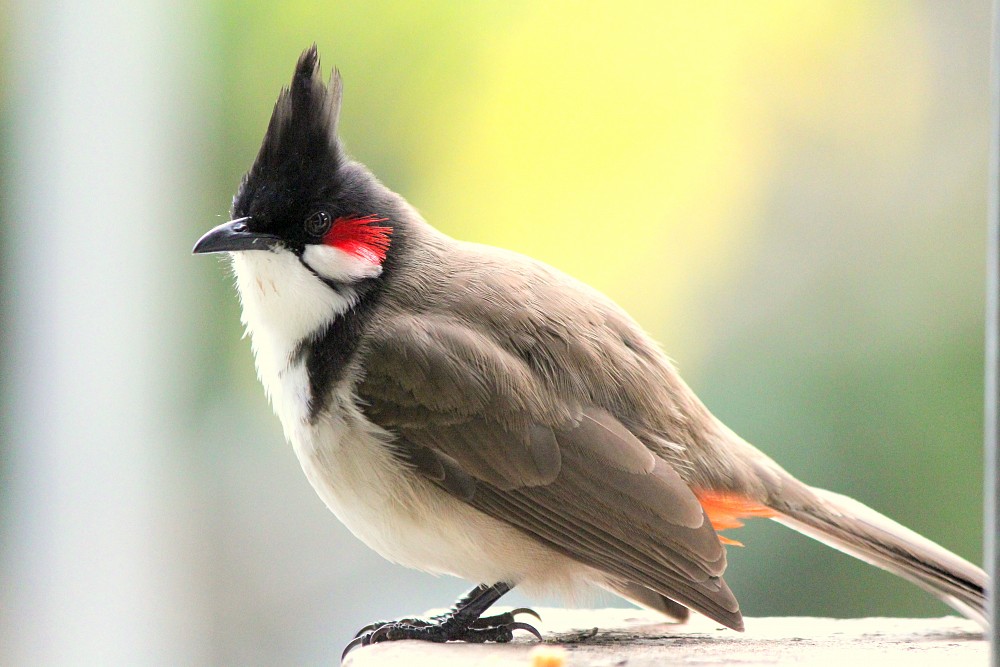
[{"xmin": 344, "ymin": 607, "xmax": 987, "ymax": 667}]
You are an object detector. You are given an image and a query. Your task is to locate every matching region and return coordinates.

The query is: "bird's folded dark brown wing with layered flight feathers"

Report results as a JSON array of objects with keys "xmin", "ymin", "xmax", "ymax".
[{"xmin": 359, "ymin": 314, "xmax": 742, "ymax": 629}]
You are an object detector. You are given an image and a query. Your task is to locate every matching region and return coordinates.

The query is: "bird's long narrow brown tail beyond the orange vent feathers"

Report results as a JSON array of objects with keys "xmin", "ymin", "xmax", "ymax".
[{"xmin": 766, "ymin": 478, "xmax": 987, "ymax": 629}]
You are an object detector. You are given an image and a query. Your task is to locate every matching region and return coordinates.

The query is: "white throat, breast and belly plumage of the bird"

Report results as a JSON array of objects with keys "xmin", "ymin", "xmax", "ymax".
[{"xmin": 233, "ymin": 251, "xmax": 600, "ymax": 592}]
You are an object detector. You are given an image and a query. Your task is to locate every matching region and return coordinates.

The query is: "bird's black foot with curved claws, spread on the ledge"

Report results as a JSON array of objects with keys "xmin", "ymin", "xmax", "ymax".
[{"xmin": 344, "ymin": 608, "xmax": 542, "ymax": 656}]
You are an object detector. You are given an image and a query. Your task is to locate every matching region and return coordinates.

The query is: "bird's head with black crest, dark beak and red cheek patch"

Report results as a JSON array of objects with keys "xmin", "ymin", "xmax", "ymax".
[{"xmin": 193, "ymin": 45, "xmax": 394, "ymax": 290}]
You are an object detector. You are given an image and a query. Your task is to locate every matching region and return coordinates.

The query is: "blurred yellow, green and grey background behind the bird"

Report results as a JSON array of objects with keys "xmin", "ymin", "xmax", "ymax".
[{"xmin": 0, "ymin": 0, "xmax": 989, "ymax": 665}]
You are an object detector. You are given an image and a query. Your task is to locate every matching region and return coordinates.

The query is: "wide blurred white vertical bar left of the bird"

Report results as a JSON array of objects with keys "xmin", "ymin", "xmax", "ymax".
[{"xmin": 0, "ymin": 0, "xmax": 205, "ymax": 665}]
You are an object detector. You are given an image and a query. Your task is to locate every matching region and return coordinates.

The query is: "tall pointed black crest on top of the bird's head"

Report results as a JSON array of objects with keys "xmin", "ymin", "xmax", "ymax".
[{"xmin": 233, "ymin": 44, "xmax": 346, "ymax": 227}]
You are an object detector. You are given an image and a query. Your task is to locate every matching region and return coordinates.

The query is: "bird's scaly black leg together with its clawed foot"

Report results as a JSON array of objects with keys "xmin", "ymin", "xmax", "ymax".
[{"xmin": 344, "ymin": 582, "xmax": 542, "ymax": 655}]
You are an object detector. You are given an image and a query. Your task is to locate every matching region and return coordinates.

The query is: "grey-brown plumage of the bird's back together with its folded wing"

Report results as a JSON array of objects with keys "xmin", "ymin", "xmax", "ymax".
[{"xmin": 358, "ymin": 237, "xmax": 742, "ymax": 628}]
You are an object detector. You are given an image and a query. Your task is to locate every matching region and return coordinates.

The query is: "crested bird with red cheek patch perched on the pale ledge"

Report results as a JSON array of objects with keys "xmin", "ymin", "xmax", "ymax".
[{"xmin": 193, "ymin": 44, "xmax": 988, "ymax": 654}]
